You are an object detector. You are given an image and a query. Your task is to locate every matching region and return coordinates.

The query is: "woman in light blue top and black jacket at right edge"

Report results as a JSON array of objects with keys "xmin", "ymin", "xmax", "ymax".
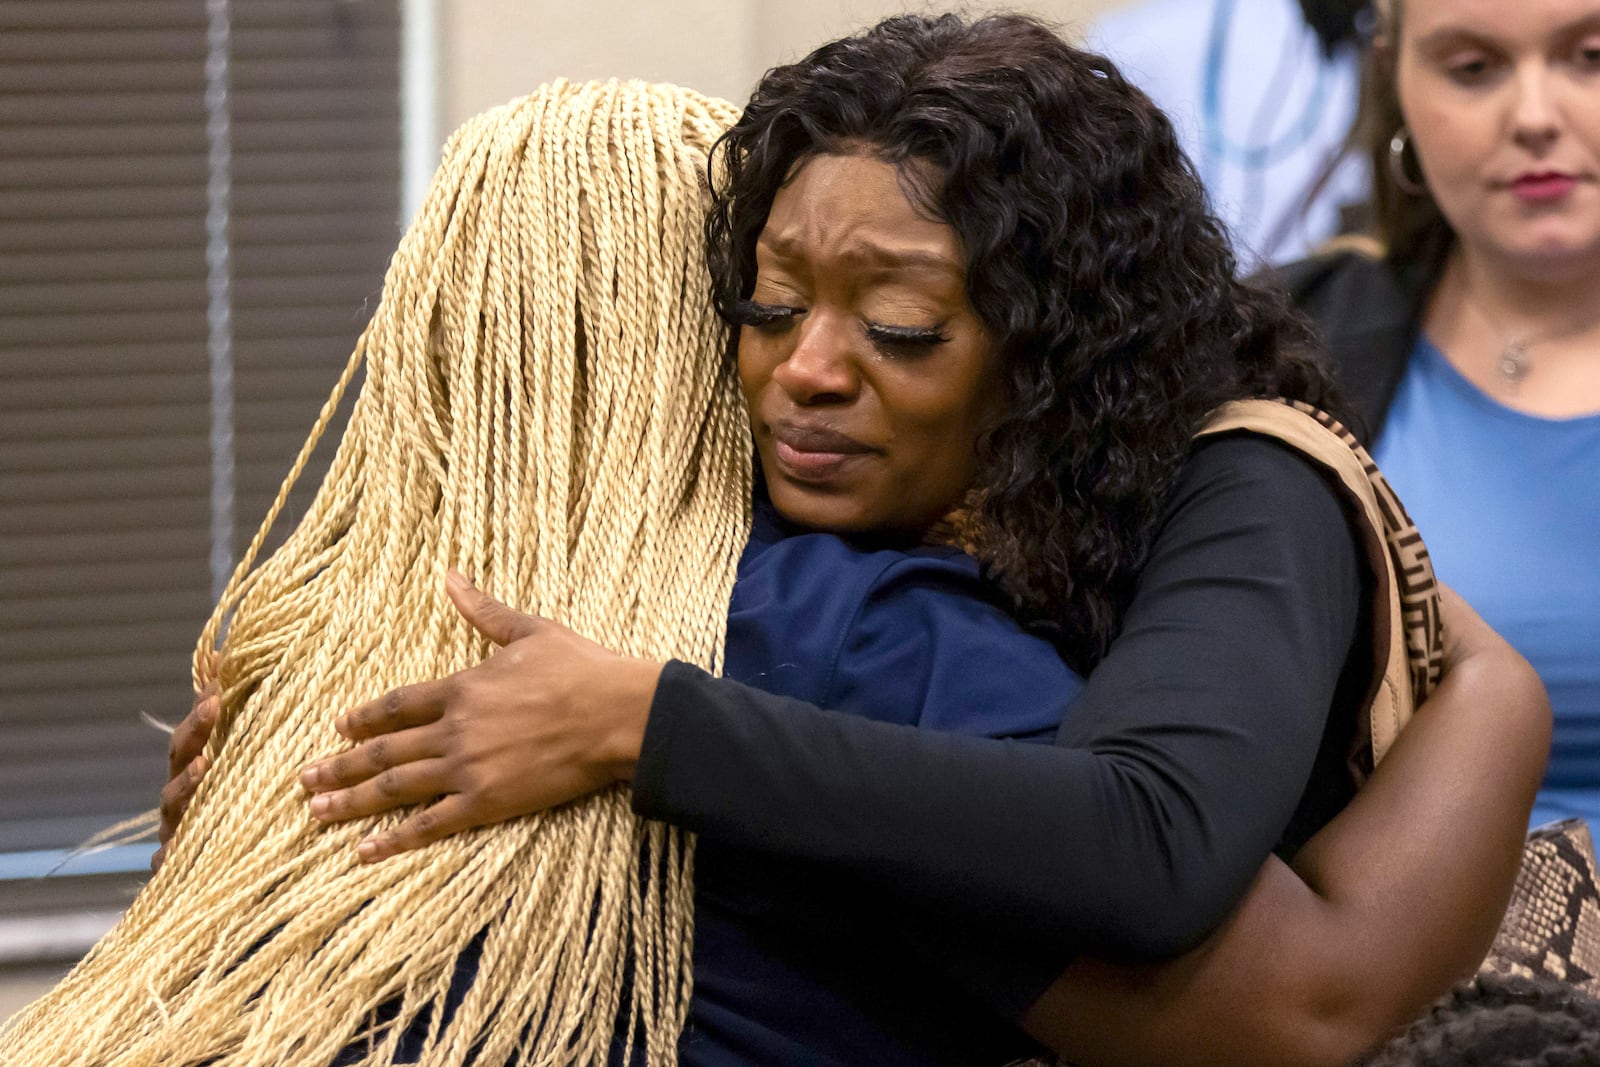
[{"xmin": 1283, "ymin": 0, "xmax": 1600, "ymax": 825}]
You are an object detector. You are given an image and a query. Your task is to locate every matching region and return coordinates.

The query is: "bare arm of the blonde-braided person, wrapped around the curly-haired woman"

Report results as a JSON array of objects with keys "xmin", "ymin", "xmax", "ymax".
[{"xmin": 1024, "ymin": 633, "xmax": 1549, "ymax": 1067}]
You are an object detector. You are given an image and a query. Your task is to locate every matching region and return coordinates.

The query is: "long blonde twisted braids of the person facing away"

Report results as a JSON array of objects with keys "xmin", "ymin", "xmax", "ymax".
[{"xmin": 0, "ymin": 82, "xmax": 750, "ymax": 1067}]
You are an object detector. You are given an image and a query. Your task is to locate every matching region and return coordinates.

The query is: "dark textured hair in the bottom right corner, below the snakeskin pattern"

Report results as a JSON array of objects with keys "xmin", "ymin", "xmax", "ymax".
[{"xmin": 1362, "ymin": 973, "xmax": 1600, "ymax": 1067}]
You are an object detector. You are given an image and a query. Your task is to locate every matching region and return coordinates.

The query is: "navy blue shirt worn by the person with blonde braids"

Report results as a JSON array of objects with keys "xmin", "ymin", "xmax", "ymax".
[{"xmin": 682, "ymin": 507, "xmax": 1082, "ymax": 1067}]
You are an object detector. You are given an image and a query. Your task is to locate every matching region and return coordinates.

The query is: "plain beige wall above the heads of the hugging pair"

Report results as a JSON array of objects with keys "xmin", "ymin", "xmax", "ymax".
[{"xmin": 438, "ymin": 0, "xmax": 1128, "ymax": 133}]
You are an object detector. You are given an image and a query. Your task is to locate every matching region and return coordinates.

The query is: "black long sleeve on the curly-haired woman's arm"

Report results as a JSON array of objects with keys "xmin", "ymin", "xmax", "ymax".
[{"xmin": 634, "ymin": 435, "xmax": 1368, "ymax": 1016}]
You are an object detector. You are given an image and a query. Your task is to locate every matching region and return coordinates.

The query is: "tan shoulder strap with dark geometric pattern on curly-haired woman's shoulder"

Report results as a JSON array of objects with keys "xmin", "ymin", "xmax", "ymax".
[{"xmin": 1195, "ymin": 400, "xmax": 1445, "ymax": 777}]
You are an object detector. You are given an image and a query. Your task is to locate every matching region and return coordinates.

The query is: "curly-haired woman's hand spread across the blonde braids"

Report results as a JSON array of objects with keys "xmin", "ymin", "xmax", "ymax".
[{"xmin": 301, "ymin": 576, "xmax": 661, "ymax": 862}]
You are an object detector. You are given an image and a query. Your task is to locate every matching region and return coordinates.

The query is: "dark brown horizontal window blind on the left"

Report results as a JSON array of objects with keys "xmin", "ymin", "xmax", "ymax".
[{"xmin": 0, "ymin": 0, "xmax": 400, "ymax": 915}]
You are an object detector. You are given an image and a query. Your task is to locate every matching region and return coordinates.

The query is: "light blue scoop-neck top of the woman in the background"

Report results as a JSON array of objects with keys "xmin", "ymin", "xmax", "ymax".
[{"xmin": 1373, "ymin": 339, "xmax": 1600, "ymax": 832}]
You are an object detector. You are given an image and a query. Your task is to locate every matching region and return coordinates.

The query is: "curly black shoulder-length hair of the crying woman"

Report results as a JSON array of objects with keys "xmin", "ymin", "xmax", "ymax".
[{"xmin": 706, "ymin": 14, "xmax": 1331, "ymax": 670}]
